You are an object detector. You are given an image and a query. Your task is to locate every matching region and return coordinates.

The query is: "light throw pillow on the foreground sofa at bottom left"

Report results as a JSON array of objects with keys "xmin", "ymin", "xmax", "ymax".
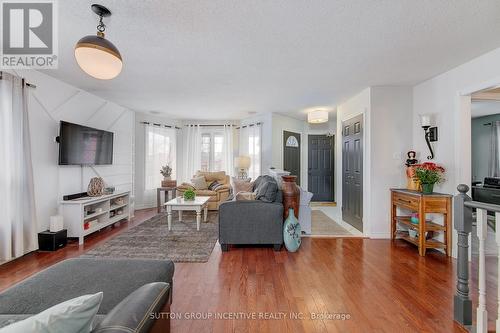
[{"xmin": 0, "ymin": 292, "xmax": 102, "ymax": 333}]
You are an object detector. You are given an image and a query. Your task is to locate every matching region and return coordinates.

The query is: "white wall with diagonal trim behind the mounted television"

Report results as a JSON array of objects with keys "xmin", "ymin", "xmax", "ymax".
[{"xmin": 14, "ymin": 70, "xmax": 135, "ymax": 231}]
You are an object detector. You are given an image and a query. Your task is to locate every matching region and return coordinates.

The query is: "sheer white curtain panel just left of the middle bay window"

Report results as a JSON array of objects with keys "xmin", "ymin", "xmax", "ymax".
[{"xmin": 180, "ymin": 125, "xmax": 201, "ymax": 182}]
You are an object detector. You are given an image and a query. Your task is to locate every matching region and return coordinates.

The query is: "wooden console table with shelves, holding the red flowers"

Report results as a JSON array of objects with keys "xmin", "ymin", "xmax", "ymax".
[{"xmin": 391, "ymin": 189, "xmax": 452, "ymax": 256}]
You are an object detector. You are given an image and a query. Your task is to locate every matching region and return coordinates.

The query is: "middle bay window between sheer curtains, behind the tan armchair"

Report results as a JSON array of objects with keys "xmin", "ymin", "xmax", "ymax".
[{"xmin": 201, "ymin": 131, "xmax": 224, "ymax": 171}]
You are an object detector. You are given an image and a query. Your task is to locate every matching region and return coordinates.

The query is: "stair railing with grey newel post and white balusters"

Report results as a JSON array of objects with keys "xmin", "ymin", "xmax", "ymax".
[{"xmin": 453, "ymin": 184, "xmax": 500, "ymax": 333}]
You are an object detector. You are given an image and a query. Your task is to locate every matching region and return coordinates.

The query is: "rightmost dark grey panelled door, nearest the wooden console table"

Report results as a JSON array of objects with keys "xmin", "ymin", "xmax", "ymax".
[{"xmin": 342, "ymin": 115, "xmax": 363, "ymax": 231}]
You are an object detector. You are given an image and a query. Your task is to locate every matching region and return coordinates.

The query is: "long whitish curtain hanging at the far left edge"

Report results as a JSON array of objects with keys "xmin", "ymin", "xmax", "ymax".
[{"xmin": 0, "ymin": 73, "xmax": 38, "ymax": 262}]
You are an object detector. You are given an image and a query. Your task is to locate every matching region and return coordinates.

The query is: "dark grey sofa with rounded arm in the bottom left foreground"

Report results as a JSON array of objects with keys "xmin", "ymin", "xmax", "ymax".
[{"xmin": 0, "ymin": 258, "xmax": 174, "ymax": 333}]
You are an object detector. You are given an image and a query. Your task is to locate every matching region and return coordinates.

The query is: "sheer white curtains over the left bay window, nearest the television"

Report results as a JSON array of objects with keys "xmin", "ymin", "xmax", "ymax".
[{"xmin": 144, "ymin": 124, "xmax": 177, "ymax": 204}]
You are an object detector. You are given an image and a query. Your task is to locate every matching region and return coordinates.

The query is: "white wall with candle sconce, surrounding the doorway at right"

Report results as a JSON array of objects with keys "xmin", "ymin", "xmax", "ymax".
[{"xmin": 413, "ymin": 48, "xmax": 500, "ymax": 194}]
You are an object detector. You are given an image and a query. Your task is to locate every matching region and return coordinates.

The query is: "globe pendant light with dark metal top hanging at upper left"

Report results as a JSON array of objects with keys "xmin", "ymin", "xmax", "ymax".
[{"xmin": 75, "ymin": 4, "xmax": 123, "ymax": 80}]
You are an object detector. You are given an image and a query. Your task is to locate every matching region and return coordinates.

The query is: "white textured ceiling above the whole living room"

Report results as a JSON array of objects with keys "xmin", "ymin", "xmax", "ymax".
[{"xmin": 42, "ymin": 0, "xmax": 500, "ymax": 119}]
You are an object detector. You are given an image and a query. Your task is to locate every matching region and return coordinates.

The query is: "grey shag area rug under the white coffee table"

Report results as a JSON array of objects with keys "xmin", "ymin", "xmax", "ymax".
[{"xmin": 82, "ymin": 212, "xmax": 219, "ymax": 262}]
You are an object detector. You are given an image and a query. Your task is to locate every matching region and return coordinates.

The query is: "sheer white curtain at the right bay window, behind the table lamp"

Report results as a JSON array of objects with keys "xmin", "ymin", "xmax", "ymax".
[{"xmin": 240, "ymin": 124, "xmax": 262, "ymax": 179}]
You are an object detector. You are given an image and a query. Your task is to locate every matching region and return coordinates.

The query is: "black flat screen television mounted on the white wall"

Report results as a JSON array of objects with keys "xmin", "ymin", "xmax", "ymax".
[{"xmin": 58, "ymin": 121, "xmax": 113, "ymax": 165}]
